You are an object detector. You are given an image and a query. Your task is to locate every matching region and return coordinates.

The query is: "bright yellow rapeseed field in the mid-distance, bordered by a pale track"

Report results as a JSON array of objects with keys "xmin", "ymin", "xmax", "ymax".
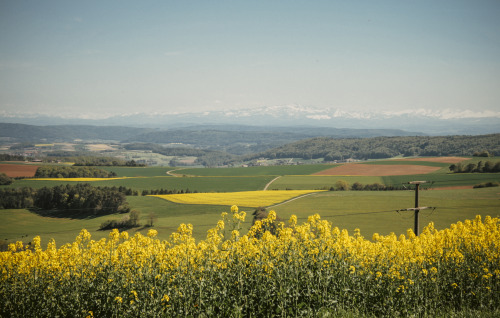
[{"xmin": 147, "ymin": 190, "xmax": 320, "ymax": 207}]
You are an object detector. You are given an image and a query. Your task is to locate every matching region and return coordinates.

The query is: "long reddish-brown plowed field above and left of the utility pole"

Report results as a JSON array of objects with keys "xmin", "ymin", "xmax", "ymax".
[{"xmin": 315, "ymin": 163, "xmax": 441, "ymax": 177}]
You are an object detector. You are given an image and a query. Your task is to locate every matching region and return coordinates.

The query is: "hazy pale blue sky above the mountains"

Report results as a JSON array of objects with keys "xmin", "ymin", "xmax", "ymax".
[{"xmin": 0, "ymin": 0, "xmax": 500, "ymax": 116}]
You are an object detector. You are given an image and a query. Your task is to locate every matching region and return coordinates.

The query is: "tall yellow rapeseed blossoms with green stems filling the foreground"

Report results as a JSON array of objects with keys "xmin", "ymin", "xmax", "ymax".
[{"xmin": 0, "ymin": 210, "xmax": 500, "ymax": 317}]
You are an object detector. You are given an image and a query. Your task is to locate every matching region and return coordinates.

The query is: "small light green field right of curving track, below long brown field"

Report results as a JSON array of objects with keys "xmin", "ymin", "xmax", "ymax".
[{"xmin": 268, "ymin": 176, "xmax": 383, "ymax": 190}]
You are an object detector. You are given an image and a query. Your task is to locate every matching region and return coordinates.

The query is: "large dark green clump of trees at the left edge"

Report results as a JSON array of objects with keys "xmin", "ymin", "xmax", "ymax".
[{"xmin": 0, "ymin": 183, "xmax": 128, "ymax": 214}]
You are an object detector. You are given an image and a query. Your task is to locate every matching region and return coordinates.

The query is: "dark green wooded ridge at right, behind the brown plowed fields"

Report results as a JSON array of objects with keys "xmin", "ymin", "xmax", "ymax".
[{"xmin": 246, "ymin": 134, "xmax": 500, "ymax": 161}]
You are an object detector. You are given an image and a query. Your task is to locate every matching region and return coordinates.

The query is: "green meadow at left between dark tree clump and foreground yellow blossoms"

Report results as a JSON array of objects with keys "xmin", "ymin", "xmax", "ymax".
[{"xmin": 0, "ymin": 196, "xmax": 248, "ymax": 248}]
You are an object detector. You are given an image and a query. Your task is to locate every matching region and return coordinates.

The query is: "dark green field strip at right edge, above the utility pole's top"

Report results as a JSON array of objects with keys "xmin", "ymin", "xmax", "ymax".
[{"xmin": 382, "ymin": 172, "xmax": 500, "ymax": 188}]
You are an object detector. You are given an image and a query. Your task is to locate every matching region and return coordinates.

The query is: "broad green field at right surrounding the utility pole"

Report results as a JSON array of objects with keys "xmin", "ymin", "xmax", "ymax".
[{"xmin": 273, "ymin": 188, "xmax": 500, "ymax": 239}]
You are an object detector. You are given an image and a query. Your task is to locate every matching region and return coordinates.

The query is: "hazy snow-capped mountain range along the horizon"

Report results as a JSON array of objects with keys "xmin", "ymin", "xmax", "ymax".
[{"xmin": 0, "ymin": 105, "xmax": 500, "ymax": 137}]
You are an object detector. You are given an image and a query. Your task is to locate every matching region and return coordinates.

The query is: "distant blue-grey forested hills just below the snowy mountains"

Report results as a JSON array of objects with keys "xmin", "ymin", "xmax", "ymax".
[{"xmin": 0, "ymin": 123, "xmax": 421, "ymax": 155}]
